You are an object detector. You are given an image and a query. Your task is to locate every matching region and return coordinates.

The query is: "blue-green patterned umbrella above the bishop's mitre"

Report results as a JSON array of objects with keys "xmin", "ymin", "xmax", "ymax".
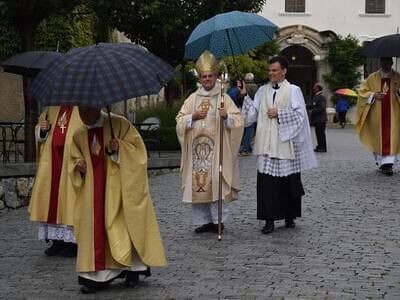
[{"xmin": 185, "ymin": 11, "xmax": 277, "ymax": 59}]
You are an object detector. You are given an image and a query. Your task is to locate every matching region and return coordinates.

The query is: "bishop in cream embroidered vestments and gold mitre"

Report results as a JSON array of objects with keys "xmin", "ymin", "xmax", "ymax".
[{"xmin": 176, "ymin": 51, "xmax": 243, "ymax": 233}]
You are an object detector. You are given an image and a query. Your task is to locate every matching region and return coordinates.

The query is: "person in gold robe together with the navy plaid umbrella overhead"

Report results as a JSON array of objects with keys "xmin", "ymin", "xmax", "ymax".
[{"xmin": 31, "ymin": 43, "xmax": 176, "ymax": 293}]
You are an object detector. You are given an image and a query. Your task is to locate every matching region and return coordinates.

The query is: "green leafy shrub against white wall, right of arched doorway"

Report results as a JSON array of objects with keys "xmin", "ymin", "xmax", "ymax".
[{"xmin": 324, "ymin": 35, "xmax": 364, "ymax": 98}]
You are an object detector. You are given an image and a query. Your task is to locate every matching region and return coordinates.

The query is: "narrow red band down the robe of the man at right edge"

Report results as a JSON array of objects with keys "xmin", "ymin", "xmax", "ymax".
[{"xmin": 381, "ymin": 78, "xmax": 391, "ymax": 155}]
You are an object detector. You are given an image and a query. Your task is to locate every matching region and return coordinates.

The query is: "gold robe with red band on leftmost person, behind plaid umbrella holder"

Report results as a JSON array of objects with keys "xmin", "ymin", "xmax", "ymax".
[{"xmin": 29, "ymin": 106, "xmax": 83, "ymax": 225}]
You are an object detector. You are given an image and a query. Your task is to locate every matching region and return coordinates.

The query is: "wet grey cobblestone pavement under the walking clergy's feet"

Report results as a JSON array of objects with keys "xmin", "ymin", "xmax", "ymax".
[{"xmin": 0, "ymin": 128, "xmax": 400, "ymax": 299}]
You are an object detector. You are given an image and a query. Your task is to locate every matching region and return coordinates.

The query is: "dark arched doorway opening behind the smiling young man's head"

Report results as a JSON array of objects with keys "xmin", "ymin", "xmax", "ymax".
[{"xmin": 281, "ymin": 45, "xmax": 317, "ymax": 104}]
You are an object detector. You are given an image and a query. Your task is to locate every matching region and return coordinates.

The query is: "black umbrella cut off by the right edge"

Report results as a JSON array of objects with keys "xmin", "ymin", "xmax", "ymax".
[{"xmin": 361, "ymin": 33, "xmax": 400, "ymax": 57}]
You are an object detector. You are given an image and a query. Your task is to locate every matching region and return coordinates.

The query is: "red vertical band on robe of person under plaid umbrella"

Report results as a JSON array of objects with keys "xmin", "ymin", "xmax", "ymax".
[{"xmin": 88, "ymin": 127, "xmax": 106, "ymax": 271}]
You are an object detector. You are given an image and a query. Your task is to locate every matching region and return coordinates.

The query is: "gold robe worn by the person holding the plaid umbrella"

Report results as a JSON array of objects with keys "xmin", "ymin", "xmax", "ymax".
[{"xmin": 69, "ymin": 114, "xmax": 166, "ymax": 272}]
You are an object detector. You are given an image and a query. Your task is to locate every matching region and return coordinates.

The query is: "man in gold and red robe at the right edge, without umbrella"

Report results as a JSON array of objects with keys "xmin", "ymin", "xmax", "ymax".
[{"xmin": 354, "ymin": 57, "xmax": 400, "ymax": 176}]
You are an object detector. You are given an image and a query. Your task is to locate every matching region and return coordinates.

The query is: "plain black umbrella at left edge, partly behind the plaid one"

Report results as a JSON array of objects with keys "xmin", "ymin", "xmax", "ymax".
[{"xmin": 0, "ymin": 51, "xmax": 63, "ymax": 77}]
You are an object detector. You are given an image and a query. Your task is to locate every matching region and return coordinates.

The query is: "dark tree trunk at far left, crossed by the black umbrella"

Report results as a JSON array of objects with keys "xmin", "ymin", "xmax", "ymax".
[{"xmin": 20, "ymin": 22, "xmax": 38, "ymax": 162}]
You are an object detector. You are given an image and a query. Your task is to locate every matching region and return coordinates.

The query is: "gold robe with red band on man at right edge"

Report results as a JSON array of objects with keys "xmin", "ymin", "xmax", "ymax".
[{"xmin": 354, "ymin": 70, "xmax": 400, "ymax": 155}]
